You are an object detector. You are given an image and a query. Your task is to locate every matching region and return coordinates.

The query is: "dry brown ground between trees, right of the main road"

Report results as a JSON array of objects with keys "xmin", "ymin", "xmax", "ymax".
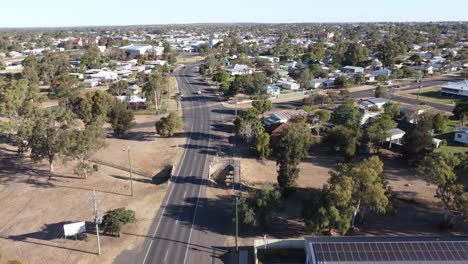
[{"xmin": 232, "ymin": 146, "xmax": 467, "ymax": 244}]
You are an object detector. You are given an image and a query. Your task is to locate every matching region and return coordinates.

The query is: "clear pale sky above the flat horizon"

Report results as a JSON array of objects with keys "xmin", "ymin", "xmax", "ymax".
[{"xmin": 0, "ymin": 0, "xmax": 468, "ymax": 28}]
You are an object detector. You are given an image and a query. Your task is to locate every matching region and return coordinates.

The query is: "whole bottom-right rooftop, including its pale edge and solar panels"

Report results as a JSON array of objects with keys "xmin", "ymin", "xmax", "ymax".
[{"xmin": 306, "ymin": 236, "xmax": 468, "ymax": 264}]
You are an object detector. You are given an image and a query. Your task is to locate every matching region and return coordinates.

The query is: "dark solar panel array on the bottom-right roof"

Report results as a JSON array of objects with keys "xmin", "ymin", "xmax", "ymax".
[{"xmin": 313, "ymin": 241, "xmax": 468, "ymax": 263}]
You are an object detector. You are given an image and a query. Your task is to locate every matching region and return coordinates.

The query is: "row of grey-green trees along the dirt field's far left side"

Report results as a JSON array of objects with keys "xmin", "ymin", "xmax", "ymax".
[{"xmin": 0, "ymin": 79, "xmax": 134, "ymax": 176}]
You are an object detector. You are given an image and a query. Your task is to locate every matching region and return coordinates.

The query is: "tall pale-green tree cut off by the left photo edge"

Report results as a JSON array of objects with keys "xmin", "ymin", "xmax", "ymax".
[{"xmin": 0, "ymin": 79, "xmax": 42, "ymax": 154}]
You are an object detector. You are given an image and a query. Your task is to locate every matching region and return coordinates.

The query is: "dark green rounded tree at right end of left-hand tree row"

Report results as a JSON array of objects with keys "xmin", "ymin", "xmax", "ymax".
[{"xmin": 109, "ymin": 100, "xmax": 136, "ymax": 136}]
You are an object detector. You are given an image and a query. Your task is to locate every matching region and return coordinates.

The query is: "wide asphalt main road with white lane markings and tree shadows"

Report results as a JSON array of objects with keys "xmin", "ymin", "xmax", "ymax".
[{"xmin": 115, "ymin": 64, "xmax": 232, "ymax": 264}]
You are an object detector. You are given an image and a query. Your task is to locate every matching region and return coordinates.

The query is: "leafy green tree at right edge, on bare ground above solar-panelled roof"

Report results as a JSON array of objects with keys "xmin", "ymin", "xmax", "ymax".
[{"xmin": 417, "ymin": 152, "xmax": 468, "ymax": 227}]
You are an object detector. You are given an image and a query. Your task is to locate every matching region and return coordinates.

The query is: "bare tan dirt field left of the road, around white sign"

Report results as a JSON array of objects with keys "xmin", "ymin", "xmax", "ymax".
[{"xmin": 0, "ymin": 76, "xmax": 185, "ymax": 263}]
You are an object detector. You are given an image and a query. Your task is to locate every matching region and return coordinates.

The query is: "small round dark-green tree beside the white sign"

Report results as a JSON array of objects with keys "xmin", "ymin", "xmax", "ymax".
[{"xmin": 101, "ymin": 208, "xmax": 136, "ymax": 237}]
